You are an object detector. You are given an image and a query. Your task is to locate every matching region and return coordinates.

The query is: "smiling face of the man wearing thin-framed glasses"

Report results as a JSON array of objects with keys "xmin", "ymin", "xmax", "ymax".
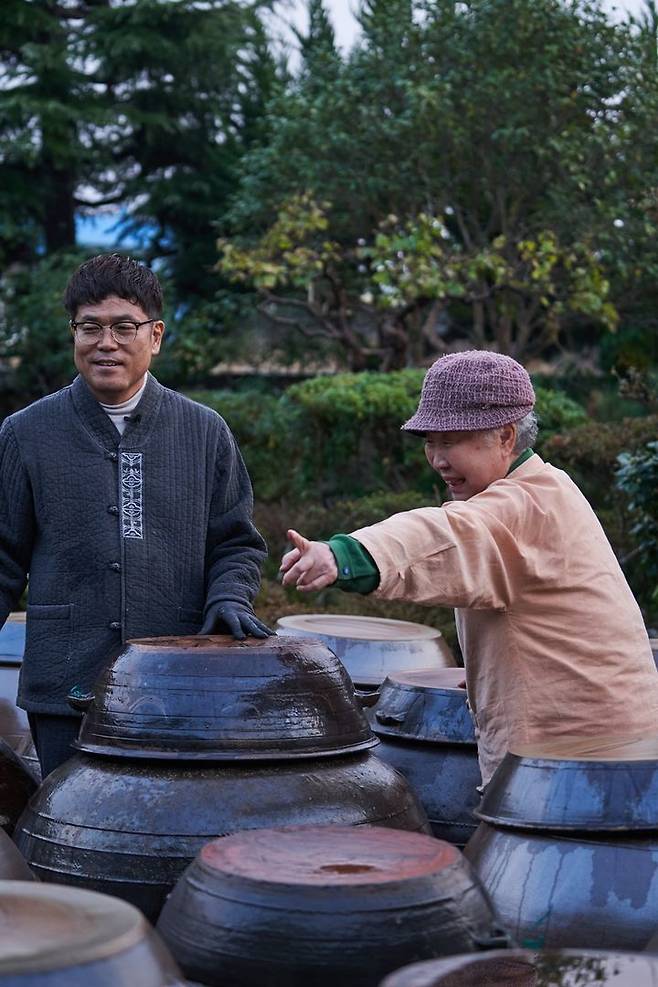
[{"xmin": 73, "ymin": 295, "xmax": 164, "ymax": 404}]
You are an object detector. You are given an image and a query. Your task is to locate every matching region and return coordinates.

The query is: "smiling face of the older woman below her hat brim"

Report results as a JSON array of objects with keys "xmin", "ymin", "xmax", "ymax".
[{"xmin": 425, "ymin": 425, "xmax": 516, "ymax": 500}]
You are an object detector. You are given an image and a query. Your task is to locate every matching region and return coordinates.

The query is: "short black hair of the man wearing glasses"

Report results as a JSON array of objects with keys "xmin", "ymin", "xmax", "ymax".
[{"xmin": 64, "ymin": 254, "xmax": 162, "ymax": 319}]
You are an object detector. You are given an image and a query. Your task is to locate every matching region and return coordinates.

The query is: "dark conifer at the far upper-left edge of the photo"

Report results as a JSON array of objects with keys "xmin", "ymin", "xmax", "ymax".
[{"xmin": 0, "ymin": 0, "xmax": 107, "ymax": 264}]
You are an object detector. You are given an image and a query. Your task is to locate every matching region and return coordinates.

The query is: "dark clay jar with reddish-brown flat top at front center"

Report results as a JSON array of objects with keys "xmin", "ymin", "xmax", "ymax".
[{"xmin": 158, "ymin": 826, "xmax": 507, "ymax": 987}]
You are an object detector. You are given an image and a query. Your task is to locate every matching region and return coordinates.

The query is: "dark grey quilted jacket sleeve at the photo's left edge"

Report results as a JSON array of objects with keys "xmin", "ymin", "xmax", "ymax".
[{"xmin": 0, "ymin": 419, "xmax": 36, "ymax": 627}]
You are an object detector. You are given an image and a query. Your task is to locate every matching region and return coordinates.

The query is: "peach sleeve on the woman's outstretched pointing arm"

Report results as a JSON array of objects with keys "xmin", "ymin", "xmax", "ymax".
[{"xmin": 352, "ymin": 503, "xmax": 524, "ymax": 611}]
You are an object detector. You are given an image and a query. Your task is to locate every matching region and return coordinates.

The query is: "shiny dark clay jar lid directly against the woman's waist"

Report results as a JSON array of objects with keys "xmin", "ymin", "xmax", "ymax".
[{"xmin": 371, "ymin": 668, "xmax": 475, "ymax": 747}]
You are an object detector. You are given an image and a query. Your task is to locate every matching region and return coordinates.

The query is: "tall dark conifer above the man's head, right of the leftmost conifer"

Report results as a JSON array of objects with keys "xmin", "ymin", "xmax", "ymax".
[{"xmin": 84, "ymin": 0, "xmax": 278, "ymax": 300}]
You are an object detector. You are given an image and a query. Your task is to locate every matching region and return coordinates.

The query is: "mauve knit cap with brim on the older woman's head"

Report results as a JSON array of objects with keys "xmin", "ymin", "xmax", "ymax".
[{"xmin": 402, "ymin": 350, "xmax": 535, "ymax": 435}]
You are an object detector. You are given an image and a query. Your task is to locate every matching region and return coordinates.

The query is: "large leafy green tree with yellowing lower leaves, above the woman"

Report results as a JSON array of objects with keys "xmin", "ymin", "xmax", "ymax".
[{"xmin": 222, "ymin": 0, "xmax": 658, "ymax": 366}]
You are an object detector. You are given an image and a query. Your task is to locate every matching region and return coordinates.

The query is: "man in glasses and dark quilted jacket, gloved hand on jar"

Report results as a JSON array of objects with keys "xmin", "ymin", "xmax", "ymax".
[{"xmin": 0, "ymin": 254, "xmax": 270, "ymax": 775}]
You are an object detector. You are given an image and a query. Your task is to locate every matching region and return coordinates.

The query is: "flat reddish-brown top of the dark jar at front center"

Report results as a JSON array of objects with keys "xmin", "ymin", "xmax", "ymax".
[{"xmin": 200, "ymin": 826, "xmax": 460, "ymax": 887}]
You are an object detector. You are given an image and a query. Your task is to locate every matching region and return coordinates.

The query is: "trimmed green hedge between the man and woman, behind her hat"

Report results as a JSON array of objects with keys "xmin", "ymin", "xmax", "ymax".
[{"xmin": 191, "ymin": 370, "xmax": 586, "ymax": 507}]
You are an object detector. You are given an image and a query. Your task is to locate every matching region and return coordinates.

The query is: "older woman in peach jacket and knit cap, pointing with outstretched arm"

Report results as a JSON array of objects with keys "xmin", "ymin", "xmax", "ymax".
[{"xmin": 281, "ymin": 351, "xmax": 658, "ymax": 785}]
